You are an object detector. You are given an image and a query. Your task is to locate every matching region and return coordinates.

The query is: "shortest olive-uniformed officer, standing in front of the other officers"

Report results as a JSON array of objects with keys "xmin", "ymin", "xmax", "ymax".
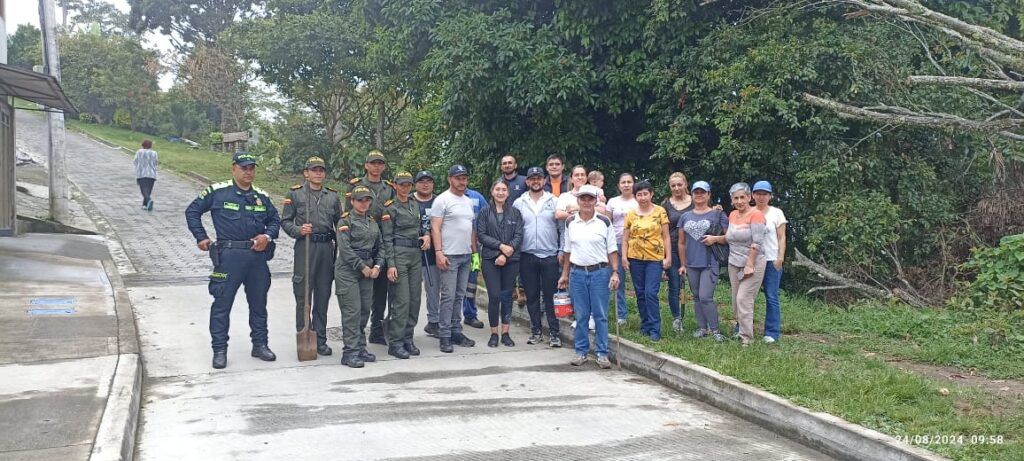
[{"xmin": 334, "ymin": 185, "xmax": 384, "ymax": 368}]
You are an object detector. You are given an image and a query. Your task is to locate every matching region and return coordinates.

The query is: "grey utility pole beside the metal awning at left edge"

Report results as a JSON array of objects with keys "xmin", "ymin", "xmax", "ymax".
[{"xmin": 39, "ymin": 0, "xmax": 70, "ymax": 222}]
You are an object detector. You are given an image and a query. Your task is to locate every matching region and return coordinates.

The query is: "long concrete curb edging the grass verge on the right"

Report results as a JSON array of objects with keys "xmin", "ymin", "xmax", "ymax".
[{"xmin": 491, "ymin": 285, "xmax": 947, "ymax": 461}]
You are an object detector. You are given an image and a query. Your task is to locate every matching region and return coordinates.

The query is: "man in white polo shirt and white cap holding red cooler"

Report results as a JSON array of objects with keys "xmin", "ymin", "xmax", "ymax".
[{"xmin": 558, "ymin": 185, "xmax": 620, "ymax": 368}]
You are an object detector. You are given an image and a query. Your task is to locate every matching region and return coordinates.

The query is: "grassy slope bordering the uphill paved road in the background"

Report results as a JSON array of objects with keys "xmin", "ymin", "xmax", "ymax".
[{"xmin": 67, "ymin": 120, "xmax": 302, "ymax": 197}]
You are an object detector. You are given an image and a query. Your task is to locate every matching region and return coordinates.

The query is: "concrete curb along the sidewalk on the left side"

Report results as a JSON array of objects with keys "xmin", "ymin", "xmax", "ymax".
[{"xmin": 89, "ymin": 260, "xmax": 144, "ymax": 461}]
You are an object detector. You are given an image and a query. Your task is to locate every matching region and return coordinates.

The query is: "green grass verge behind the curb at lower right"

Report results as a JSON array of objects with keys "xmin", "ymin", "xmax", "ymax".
[{"xmin": 610, "ymin": 281, "xmax": 1024, "ymax": 460}]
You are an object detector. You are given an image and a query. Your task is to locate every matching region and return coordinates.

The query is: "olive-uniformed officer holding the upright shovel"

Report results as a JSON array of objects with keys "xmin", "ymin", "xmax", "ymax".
[{"xmin": 281, "ymin": 157, "xmax": 341, "ymax": 355}]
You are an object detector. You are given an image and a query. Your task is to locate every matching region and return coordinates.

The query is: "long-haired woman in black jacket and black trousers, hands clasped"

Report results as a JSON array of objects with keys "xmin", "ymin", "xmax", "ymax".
[{"xmin": 476, "ymin": 179, "xmax": 522, "ymax": 347}]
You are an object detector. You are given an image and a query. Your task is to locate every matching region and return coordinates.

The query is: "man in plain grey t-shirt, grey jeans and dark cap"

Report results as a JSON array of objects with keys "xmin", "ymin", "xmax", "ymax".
[{"xmin": 430, "ymin": 165, "xmax": 476, "ymax": 352}]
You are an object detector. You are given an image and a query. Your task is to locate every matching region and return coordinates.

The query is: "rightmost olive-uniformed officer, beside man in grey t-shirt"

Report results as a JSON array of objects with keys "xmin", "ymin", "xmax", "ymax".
[{"xmin": 381, "ymin": 171, "xmax": 429, "ymax": 359}]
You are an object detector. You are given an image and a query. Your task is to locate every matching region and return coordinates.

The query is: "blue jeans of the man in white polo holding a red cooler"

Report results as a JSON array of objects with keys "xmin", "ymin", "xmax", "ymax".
[{"xmin": 569, "ymin": 267, "xmax": 611, "ymax": 357}]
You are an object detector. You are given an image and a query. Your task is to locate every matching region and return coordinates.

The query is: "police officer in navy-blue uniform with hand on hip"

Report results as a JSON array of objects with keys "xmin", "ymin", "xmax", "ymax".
[{"xmin": 185, "ymin": 152, "xmax": 281, "ymax": 369}]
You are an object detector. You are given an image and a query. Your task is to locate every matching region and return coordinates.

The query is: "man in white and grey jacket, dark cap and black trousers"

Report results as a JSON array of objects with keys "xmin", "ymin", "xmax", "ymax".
[{"xmin": 512, "ymin": 167, "xmax": 562, "ymax": 347}]
